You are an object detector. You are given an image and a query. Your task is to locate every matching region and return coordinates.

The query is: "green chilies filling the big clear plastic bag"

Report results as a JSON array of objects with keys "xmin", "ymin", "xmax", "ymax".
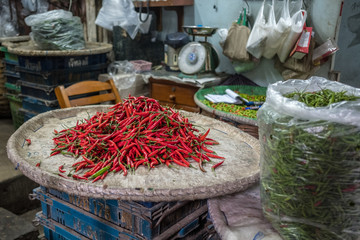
[{"xmin": 258, "ymin": 90, "xmax": 360, "ymax": 240}]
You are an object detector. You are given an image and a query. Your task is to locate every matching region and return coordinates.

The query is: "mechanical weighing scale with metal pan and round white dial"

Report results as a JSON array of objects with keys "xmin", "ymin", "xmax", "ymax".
[{"xmin": 178, "ymin": 26, "xmax": 219, "ymax": 78}]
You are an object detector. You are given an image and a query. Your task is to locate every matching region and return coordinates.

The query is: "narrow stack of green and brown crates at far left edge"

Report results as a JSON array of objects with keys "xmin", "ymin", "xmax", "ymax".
[{"xmin": 0, "ymin": 46, "xmax": 24, "ymax": 129}]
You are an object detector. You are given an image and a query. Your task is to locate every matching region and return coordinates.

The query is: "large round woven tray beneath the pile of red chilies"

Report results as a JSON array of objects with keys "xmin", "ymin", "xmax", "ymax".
[{"xmin": 7, "ymin": 106, "xmax": 260, "ymax": 202}]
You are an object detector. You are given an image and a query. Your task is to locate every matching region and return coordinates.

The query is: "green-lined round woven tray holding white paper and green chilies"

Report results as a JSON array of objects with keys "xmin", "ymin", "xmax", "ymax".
[{"xmin": 194, "ymin": 85, "xmax": 267, "ymax": 138}]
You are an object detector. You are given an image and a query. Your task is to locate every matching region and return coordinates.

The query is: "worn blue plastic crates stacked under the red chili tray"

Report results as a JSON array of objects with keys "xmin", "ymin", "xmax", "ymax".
[{"xmin": 32, "ymin": 187, "xmax": 208, "ymax": 240}]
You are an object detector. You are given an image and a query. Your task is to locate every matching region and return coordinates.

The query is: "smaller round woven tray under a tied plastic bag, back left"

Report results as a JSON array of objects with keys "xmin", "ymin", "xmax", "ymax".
[{"xmin": 3, "ymin": 41, "xmax": 112, "ymax": 56}]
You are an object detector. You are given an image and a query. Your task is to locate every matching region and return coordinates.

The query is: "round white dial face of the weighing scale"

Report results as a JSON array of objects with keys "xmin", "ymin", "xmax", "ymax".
[{"xmin": 179, "ymin": 42, "xmax": 207, "ymax": 74}]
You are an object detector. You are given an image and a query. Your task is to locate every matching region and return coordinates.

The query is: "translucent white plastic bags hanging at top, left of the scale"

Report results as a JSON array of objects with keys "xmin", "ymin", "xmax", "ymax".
[{"xmin": 95, "ymin": 0, "xmax": 152, "ymax": 39}]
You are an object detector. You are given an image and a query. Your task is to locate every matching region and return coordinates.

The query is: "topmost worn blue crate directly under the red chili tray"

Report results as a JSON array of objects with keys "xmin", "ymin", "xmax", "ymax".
[{"xmin": 34, "ymin": 187, "xmax": 207, "ymax": 239}]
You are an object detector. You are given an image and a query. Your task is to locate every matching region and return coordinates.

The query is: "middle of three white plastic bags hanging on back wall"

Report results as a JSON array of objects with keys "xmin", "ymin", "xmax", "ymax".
[{"xmin": 263, "ymin": 0, "xmax": 292, "ymax": 59}]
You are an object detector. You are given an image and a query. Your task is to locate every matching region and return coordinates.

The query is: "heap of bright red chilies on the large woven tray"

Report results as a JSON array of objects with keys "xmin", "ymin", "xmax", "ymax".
[{"xmin": 51, "ymin": 96, "xmax": 224, "ymax": 182}]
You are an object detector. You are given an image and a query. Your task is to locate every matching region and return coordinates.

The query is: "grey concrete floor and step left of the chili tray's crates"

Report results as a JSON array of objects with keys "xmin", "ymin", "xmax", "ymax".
[{"xmin": 0, "ymin": 118, "xmax": 41, "ymax": 240}]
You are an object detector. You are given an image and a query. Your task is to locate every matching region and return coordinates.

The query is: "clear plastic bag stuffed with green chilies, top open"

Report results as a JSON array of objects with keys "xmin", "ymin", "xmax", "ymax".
[{"xmin": 258, "ymin": 77, "xmax": 360, "ymax": 240}]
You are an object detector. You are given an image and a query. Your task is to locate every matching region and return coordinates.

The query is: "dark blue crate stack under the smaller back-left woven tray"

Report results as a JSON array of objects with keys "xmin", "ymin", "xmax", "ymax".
[{"xmin": 18, "ymin": 53, "xmax": 107, "ymax": 121}]
